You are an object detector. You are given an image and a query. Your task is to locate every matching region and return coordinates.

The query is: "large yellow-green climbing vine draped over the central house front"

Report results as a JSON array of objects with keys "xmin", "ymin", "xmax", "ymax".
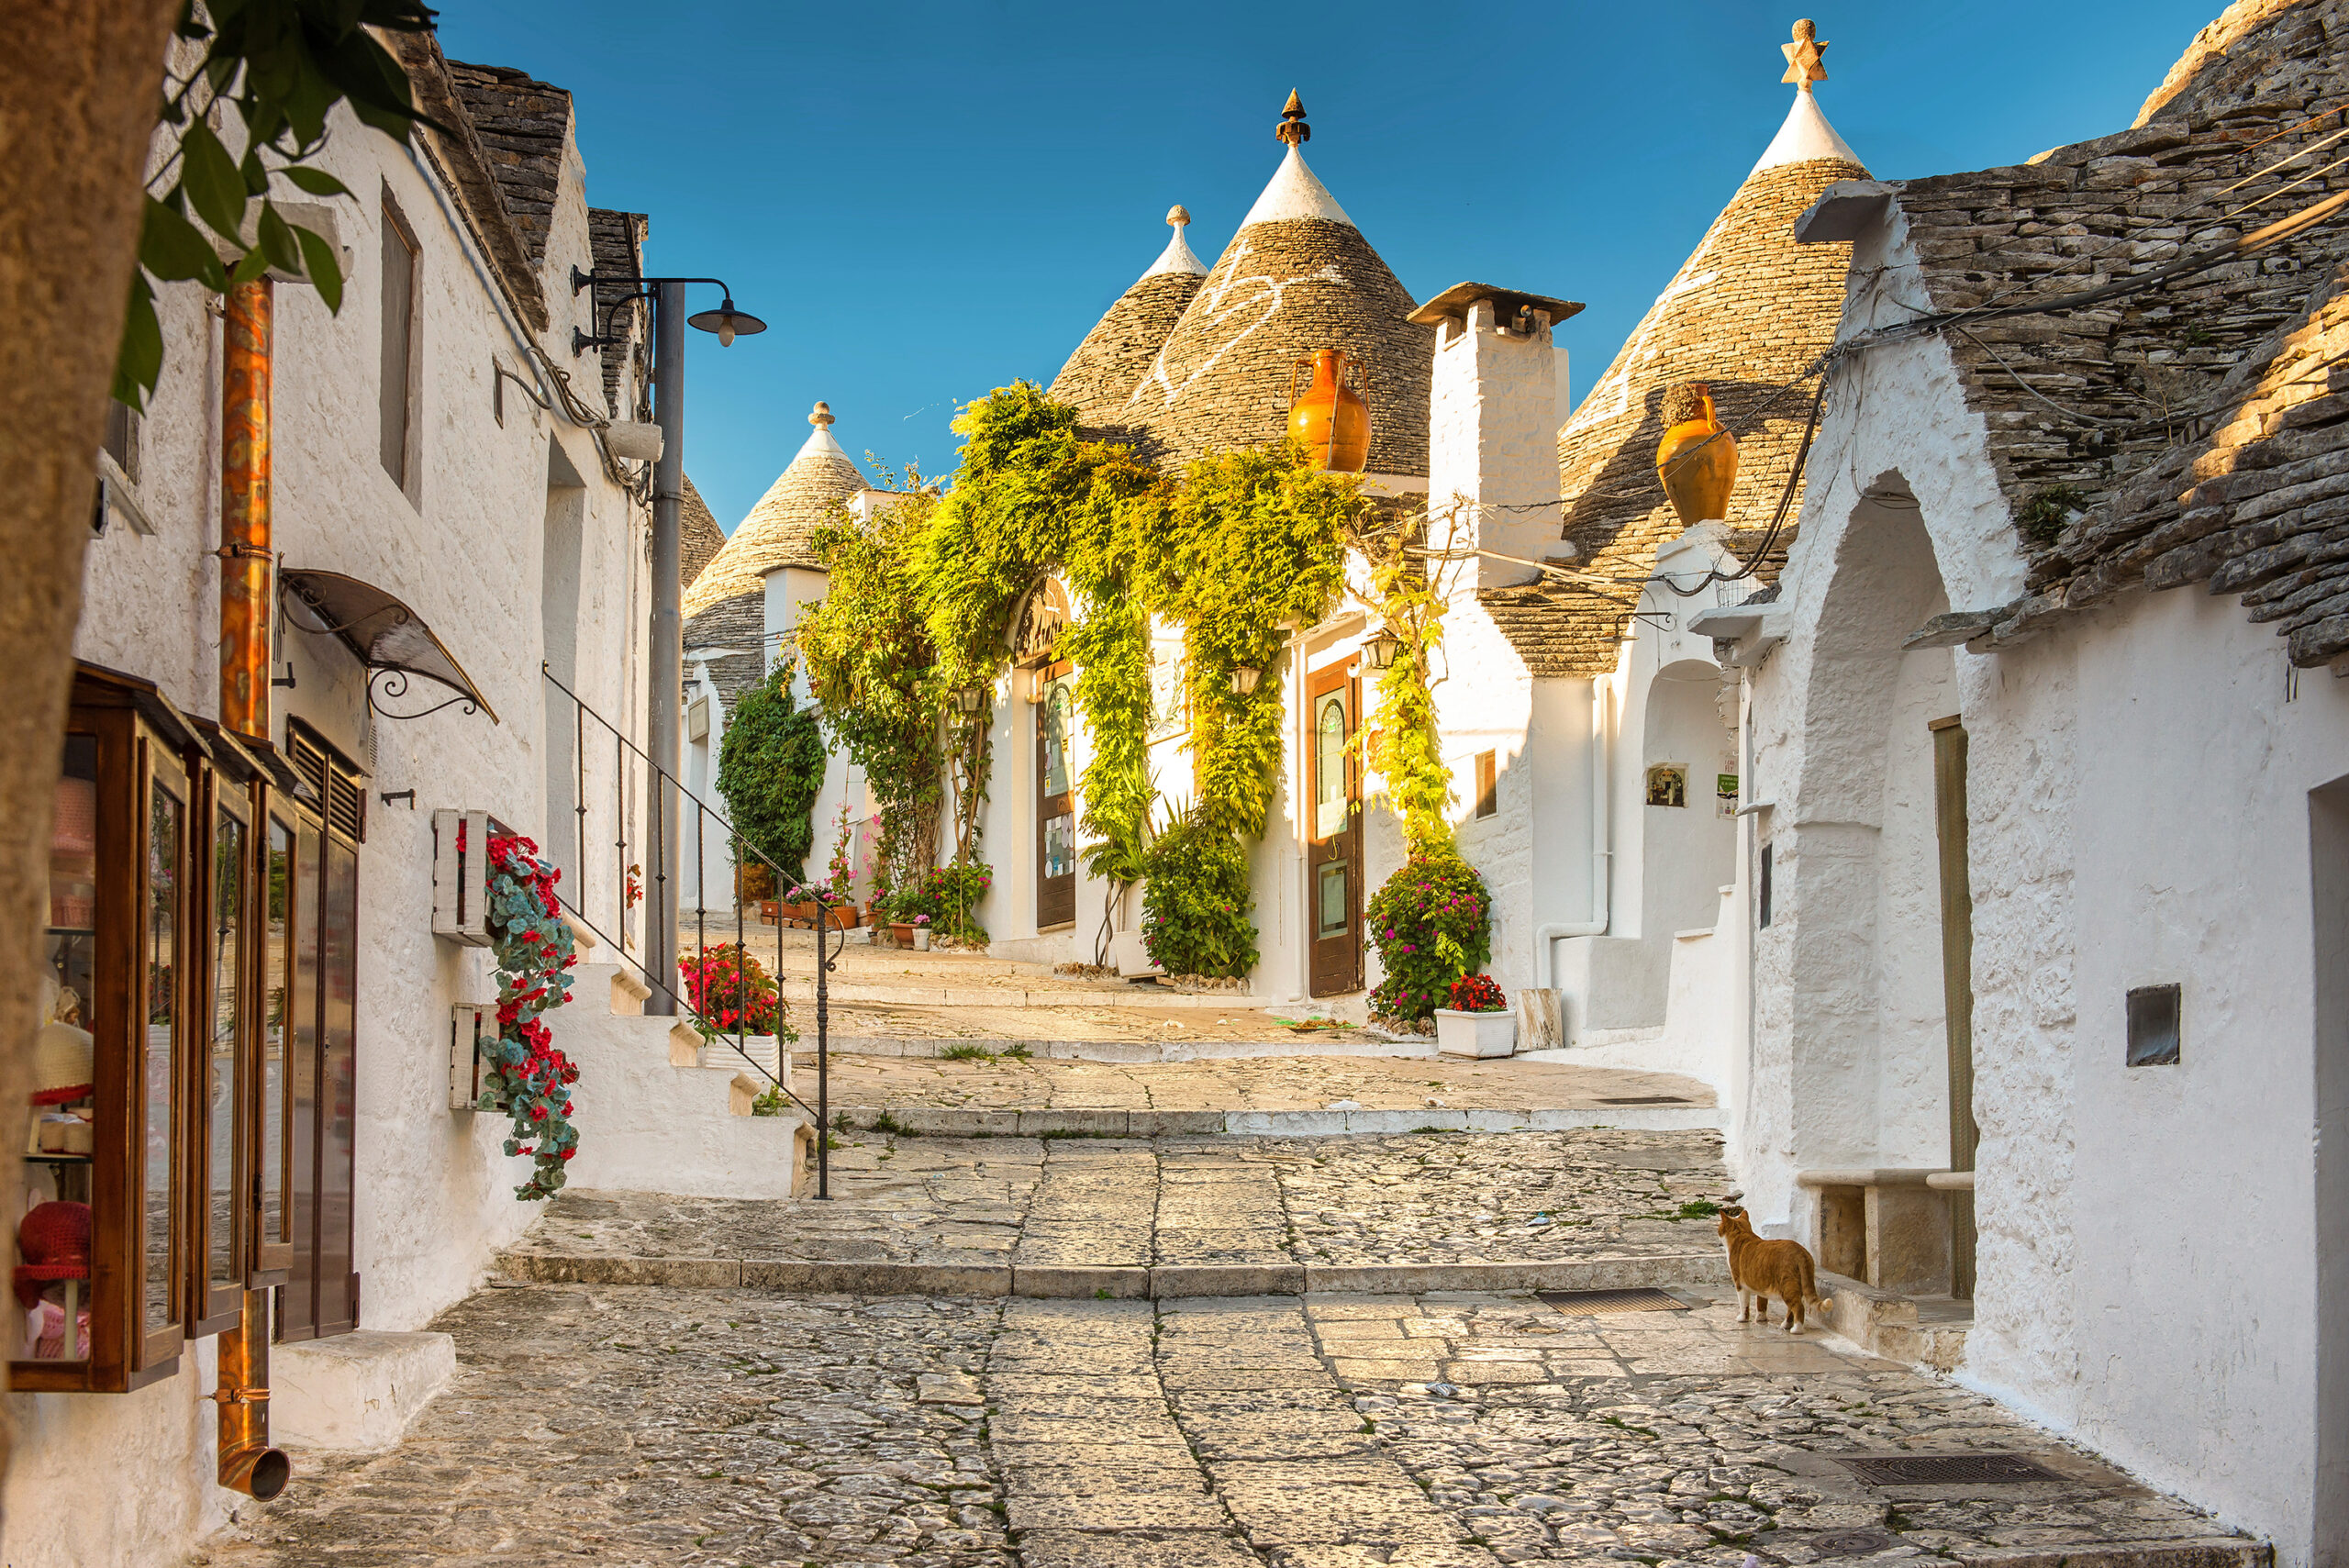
[{"xmin": 798, "ymin": 383, "xmax": 1367, "ymax": 974}]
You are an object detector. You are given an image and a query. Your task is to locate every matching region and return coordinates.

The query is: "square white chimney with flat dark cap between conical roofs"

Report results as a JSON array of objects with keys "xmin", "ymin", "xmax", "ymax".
[{"xmin": 1412, "ymin": 284, "xmax": 1581, "ymax": 589}]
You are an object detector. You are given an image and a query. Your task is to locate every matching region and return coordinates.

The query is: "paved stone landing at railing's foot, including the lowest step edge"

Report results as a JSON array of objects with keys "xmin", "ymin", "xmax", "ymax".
[{"xmin": 505, "ymin": 1129, "xmax": 1727, "ymax": 1296}]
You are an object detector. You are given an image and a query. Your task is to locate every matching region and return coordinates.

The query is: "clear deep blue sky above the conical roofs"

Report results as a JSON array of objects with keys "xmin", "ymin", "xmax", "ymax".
[{"xmin": 441, "ymin": 0, "xmax": 2220, "ymax": 530}]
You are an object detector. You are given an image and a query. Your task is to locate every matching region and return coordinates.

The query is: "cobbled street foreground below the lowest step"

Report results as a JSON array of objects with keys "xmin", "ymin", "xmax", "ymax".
[{"xmin": 197, "ymin": 1286, "xmax": 2262, "ymax": 1568}]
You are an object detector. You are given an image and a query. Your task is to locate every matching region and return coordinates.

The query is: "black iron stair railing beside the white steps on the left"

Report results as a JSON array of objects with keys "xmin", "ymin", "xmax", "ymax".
[{"xmin": 538, "ymin": 664, "xmax": 848, "ymax": 1197}]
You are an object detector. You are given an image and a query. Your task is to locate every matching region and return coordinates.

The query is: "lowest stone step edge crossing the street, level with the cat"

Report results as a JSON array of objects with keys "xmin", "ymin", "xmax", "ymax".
[{"xmin": 498, "ymin": 1251, "xmax": 1729, "ymax": 1300}]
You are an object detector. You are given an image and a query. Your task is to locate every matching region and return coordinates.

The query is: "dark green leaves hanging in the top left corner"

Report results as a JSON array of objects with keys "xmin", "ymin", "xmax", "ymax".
[{"xmin": 113, "ymin": 0, "xmax": 435, "ymax": 408}]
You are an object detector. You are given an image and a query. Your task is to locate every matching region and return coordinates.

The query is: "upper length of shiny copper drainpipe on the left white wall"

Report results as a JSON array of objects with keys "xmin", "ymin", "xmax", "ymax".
[{"xmin": 214, "ymin": 277, "xmax": 275, "ymax": 740}]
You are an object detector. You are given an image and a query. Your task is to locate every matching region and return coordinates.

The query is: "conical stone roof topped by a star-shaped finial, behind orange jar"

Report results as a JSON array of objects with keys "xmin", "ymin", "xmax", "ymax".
[{"xmin": 1494, "ymin": 24, "xmax": 1867, "ymax": 676}]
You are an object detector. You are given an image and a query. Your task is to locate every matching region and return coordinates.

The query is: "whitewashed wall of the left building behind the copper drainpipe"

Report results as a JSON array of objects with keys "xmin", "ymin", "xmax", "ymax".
[{"xmin": 5, "ymin": 97, "xmax": 646, "ymax": 1568}]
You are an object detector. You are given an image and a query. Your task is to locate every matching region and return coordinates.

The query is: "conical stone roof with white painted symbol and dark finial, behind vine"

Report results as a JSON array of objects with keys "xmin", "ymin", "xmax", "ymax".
[{"xmin": 1108, "ymin": 94, "xmax": 1435, "ymax": 476}]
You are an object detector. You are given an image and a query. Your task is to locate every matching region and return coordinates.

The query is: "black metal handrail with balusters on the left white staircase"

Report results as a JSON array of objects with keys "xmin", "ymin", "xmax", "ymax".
[{"xmin": 538, "ymin": 662, "xmax": 848, "ymax": 1197}]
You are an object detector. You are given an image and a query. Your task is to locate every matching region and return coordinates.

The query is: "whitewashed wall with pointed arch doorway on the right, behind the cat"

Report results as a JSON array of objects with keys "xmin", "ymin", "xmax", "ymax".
[{"xmin": 1733, "ymin": 202, "xmax": 2349, "ymax": 1568}]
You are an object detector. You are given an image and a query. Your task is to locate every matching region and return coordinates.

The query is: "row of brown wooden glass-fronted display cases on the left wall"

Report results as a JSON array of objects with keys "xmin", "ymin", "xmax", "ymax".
[{"xmin": 7, "ymin": 667, "xmax": 360, "ymax": 1392}]
